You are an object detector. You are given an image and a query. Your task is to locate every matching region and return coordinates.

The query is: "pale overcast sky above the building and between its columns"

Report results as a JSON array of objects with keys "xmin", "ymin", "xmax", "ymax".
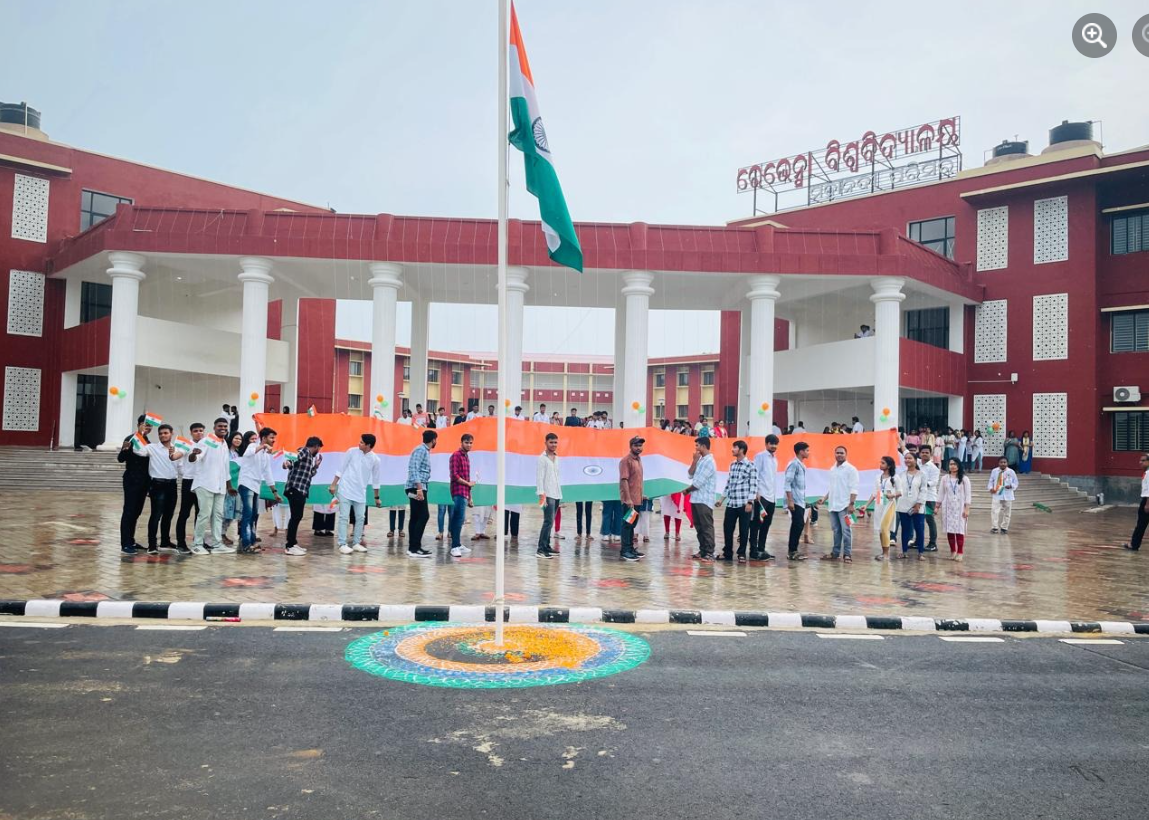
[{"xmin": 0, "ymin": 0, "xmax": 1149, "ymax": 355}]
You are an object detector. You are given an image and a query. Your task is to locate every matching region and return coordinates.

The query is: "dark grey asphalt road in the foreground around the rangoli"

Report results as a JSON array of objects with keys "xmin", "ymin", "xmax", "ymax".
[{"xmin": 0, "ymin": 626, "xmax": 1149, "ymax": 820}]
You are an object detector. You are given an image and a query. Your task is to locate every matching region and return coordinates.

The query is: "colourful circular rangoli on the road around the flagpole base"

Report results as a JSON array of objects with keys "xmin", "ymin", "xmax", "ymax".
[{"xmin": 344, "ymin": 622, "xmax": 650, "ymax": 689}]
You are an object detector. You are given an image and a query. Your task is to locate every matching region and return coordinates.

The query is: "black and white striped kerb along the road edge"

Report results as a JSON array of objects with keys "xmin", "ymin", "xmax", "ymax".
[{"xmin": 0, "ymin": 599, "xmax": 1149, "ymax": 635}]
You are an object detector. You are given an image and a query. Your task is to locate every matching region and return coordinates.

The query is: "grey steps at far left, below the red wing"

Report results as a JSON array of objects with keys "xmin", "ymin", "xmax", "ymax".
[{"xmin": 0, "ymin": 447, "xmax": 124, "ymax": 493}]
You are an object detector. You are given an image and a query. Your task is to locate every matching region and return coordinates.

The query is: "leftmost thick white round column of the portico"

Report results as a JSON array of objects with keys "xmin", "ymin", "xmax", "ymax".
[{"xmin": 99, "ymin": 250, "xmax": 145, "ymax": 450}]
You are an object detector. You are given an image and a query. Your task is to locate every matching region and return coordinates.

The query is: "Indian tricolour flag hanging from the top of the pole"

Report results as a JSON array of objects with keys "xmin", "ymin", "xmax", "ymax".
[{"xmin": 508, "ymin": 3, "xmax": 583, "ymax": 272}]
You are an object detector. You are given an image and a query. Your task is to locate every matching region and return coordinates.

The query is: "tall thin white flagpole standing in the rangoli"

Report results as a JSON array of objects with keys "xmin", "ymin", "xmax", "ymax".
[{"xmin": 494, "ymin": 0, "xmax": 507, "ymax": 648}]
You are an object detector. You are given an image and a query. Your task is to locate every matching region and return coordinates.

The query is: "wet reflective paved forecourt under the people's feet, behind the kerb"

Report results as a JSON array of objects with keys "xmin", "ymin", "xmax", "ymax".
[{"xmin": 0, "ymin": 484, "xmax": 1149, "ymax": 621}]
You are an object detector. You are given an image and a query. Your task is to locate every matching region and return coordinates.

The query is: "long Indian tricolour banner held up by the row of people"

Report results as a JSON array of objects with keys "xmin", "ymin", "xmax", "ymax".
[{"xmin": 255, "ymin": 413, "xmax": 897, "ymax": 506}]
